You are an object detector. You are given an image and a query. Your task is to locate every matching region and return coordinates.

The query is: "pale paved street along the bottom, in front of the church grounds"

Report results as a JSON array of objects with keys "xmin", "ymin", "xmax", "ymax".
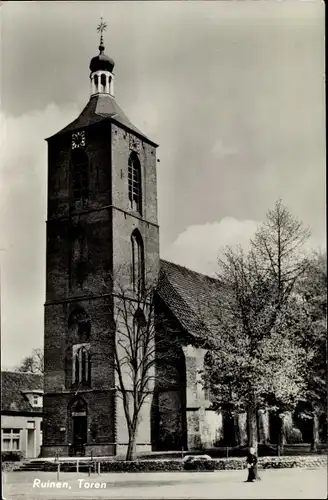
[{"xmin": 3, "ymin": 468, "xmax": 327, "ymax": 500}]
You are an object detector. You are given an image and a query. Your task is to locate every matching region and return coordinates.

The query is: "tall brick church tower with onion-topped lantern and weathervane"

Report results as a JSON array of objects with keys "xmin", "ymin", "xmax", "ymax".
[{"xmin": 42, "ymin": 22, "xmax": 159, "ymax": 457}]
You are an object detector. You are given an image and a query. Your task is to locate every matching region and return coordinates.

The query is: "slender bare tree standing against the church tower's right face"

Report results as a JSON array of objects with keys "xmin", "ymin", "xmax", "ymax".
[{"xmin": 91, "ymin": 272, "xmax": 178, "ymax": 460}]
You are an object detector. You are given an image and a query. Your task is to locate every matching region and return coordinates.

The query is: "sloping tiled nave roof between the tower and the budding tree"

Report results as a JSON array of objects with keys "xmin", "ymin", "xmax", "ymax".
[{"xmin": 158, "ymin": 259, "xmax": 219, "ymax": 339}]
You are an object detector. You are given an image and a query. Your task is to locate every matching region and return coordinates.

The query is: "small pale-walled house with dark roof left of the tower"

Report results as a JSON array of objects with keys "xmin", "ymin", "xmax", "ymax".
[{"xmin": 1, "ymin": 371, "xmax": 43, "ymax": 458}]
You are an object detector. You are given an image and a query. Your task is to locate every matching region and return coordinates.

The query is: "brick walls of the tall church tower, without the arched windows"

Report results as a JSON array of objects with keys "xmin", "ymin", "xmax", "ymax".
[{"xmin": 43, "ymin": 115, "xmax": 159, "ymax": 456}]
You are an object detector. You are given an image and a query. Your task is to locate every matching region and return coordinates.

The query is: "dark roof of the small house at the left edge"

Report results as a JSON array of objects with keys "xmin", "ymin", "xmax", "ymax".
[{"xmin": 1, "ymin": 371, "xmax": 43, "ymax": 413}]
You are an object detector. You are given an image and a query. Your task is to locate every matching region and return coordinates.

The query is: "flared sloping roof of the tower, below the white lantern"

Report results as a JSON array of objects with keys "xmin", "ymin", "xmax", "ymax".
[{"xmin": 48, "ymin": 94, "xmax": 157, "ymax": 146}]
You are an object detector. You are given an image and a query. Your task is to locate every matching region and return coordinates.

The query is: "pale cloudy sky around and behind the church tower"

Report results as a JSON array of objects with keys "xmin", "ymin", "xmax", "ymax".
[{"xmin": 0, "ymin": 0, "xmax": 326, "ymax": 367}]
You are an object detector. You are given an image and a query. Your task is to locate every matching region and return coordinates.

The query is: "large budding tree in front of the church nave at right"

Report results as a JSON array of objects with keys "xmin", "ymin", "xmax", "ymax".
[{"xmin": 205, "ymin": 200, "xmax": 308, "ymax": 458}]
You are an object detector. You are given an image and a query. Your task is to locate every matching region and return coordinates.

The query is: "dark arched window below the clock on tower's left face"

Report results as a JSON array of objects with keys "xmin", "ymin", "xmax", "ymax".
[{"xmin": 71, "ymin": 148, "xmax": 89, "ymax": 205}]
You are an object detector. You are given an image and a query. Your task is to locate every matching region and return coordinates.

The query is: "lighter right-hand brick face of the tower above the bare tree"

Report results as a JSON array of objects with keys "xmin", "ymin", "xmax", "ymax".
[{"xmin": 112, "ymin": 125, "xmax": 159, "ymax": 287}]
